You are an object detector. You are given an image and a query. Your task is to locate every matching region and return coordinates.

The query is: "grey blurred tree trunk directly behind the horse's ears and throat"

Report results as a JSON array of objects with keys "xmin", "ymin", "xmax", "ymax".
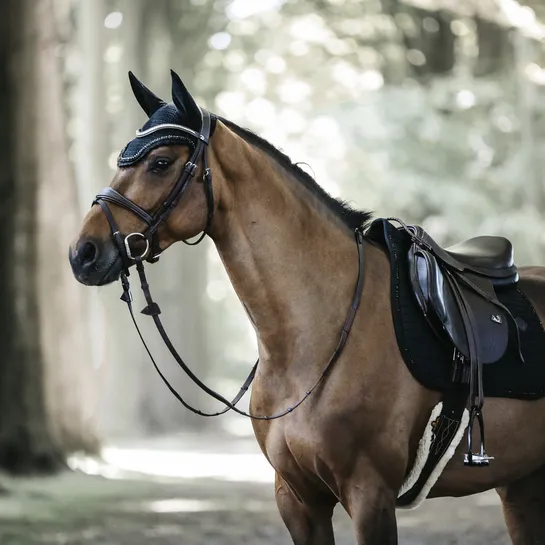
[{"xmin": 133, "ymin": 0, "xmax": 216, "ymax": 434}]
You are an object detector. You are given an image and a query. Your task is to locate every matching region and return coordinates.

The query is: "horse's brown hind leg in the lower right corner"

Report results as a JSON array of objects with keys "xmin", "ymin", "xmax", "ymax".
[{"xmin": 497, "ymin": 466, "xmax": 545, "ymax": 545}]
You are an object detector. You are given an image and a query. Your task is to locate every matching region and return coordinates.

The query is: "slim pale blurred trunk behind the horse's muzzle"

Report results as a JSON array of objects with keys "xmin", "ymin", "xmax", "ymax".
[{"xmin": 73, "ymin": 0, "xmax": 146, "ymax": 439}]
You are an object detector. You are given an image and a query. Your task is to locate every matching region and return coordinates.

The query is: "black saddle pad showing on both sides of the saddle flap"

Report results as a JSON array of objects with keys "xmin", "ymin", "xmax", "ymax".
[{"xmin": 366, "ymin": 219, "xmax": 545, "ymax": 400}]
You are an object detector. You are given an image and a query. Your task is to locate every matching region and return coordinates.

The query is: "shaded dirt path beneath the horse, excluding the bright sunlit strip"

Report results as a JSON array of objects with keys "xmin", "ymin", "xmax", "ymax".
[{"xmin": 0, "ymin": 475, "xmax": 509, "ymax": 545}]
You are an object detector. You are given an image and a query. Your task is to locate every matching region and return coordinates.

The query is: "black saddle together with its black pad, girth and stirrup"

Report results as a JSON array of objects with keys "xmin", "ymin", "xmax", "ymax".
[{"xmin": 366, "ymin": 218, "xmax": 545, "ymax": 478}]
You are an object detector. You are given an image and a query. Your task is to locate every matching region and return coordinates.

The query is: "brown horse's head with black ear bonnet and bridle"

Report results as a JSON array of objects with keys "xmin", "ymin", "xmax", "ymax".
[{"xmin": 69, "ymin": 72, "xmax": 215, "ymax": 285}]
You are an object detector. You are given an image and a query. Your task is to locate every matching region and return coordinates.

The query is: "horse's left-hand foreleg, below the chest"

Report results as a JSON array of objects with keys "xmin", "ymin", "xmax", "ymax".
[{"xmin": 275, "ymin": 473, "xmax": 335, "ymax": 545}]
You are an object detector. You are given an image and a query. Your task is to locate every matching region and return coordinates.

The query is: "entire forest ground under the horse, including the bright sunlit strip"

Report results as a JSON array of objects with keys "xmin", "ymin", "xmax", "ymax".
[{"xmin": 0, "ymin": 432, "xmax": 510, "ymax": 545}]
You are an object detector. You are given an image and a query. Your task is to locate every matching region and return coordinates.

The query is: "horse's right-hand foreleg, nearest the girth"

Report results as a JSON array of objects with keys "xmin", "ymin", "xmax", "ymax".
[{"xmin": 343, "ymin": 479, "xmax": 397, "ymax": 545}]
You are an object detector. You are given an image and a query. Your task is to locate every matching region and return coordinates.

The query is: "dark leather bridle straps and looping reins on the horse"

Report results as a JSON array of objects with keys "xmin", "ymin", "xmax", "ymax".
[{"xmin": 93, "ymin": 109, "xmax": 364, "ymax": 420}]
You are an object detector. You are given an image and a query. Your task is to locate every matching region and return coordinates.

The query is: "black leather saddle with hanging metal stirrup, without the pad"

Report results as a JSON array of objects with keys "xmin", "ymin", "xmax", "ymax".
[{"xmin": 402, "ymin": 220, "xmax": 522, "ymax": 466}]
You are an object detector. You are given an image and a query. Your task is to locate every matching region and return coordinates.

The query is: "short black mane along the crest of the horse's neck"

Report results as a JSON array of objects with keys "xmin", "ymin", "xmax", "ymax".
[{"xmin": 218, "ymin": 117, "xmax": 371, "ymax": 230}]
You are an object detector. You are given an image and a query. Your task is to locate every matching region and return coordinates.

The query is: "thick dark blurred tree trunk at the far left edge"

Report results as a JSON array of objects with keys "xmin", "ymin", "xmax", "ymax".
[{"xmin": 0, "ymin": 0, "xmax": 97, "ymax": 473}]
